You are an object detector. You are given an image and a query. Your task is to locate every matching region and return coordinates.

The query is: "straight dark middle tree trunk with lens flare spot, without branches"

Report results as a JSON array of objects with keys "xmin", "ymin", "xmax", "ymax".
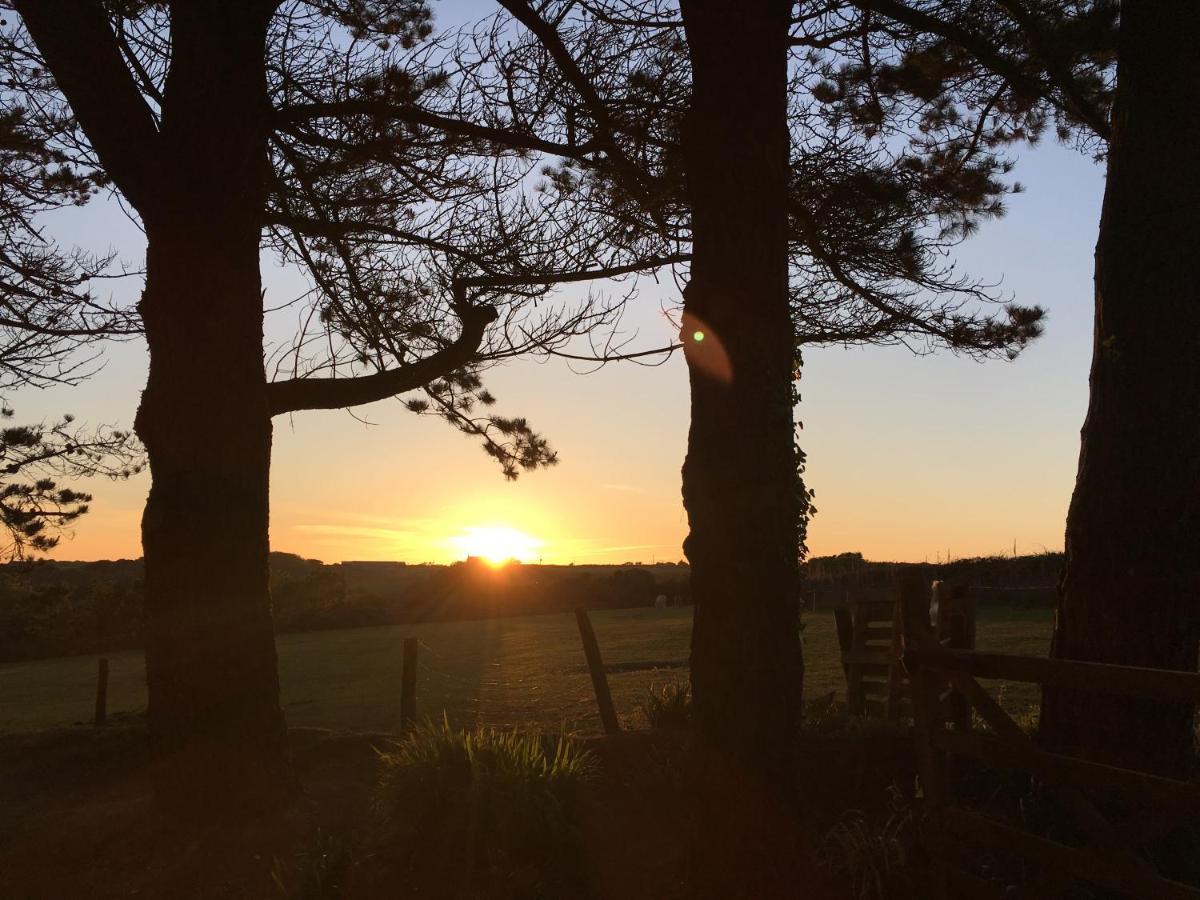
[{"xmin": 680, "ymin": 0, "xmax": 803, "ymax": 896}]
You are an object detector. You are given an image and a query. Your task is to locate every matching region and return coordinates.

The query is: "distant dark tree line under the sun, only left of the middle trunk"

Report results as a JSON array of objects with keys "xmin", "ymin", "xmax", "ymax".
[{"xmin": 0, "ymin": 553, "xmax": 690, "ymax": 661}]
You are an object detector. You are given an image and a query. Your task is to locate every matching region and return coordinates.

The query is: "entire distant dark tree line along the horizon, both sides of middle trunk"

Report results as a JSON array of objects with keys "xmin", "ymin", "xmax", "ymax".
[{"xmin": 0, "ymin": 553, "xmax": 1063, "ymax": 661}]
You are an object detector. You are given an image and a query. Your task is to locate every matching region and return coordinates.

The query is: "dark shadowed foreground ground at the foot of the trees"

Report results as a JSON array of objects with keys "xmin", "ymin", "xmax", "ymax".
[{"xmin": 0, "ymin": 716, "xmax": 908, "ymax": 900}]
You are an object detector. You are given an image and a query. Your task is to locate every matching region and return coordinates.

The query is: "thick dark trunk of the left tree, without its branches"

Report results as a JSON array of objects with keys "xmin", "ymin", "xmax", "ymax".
[{"xmin": 137, "ymin": 2, "xmax": 290, "ymax": 820}]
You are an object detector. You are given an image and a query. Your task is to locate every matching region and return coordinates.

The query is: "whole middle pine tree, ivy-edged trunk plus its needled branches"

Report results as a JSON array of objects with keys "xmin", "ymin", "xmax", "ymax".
[{"xmin": 429, "ymin": 0, "xmax": 1042, "ymax": 854}]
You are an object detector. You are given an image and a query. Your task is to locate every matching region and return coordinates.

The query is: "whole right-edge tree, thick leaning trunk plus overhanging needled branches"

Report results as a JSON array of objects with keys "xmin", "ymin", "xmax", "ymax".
[{"xmin": 835, "ymin": 0, "xmax": 1200, "ymax": 775}]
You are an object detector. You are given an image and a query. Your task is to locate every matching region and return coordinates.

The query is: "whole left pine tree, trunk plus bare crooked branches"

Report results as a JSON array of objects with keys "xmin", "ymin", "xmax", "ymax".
[{"xmin": 0, "ymin": 0, "xmax": 667, "ymax": 817}]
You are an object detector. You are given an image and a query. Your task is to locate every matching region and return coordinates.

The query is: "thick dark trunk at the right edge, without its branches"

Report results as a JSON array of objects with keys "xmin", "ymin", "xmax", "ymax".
[{"xmin": 1042, "ymin": 0, "xmax": 1200, "ymax": 775}]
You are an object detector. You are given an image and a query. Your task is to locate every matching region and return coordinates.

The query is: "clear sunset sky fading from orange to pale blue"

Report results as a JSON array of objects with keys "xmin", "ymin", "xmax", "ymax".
[{"xmin": 6, "ymin": 5, "xmax": 1104, "ymax": 564}]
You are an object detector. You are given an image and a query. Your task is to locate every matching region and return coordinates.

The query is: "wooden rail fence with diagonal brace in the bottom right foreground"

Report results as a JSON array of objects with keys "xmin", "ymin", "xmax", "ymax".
[{"xmin": 901, "ymin": 584, "xmax": 1200, "ymax": 900}]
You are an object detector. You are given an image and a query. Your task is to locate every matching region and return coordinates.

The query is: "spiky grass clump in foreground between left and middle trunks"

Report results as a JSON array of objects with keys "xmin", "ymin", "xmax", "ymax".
[{"xmin": 374, "ymin": 718, "xmax": 594, "ymax": 900}]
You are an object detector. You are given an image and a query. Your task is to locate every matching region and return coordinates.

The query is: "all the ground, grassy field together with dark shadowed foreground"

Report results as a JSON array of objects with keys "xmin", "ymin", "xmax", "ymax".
[{"xmin": 0, "ymin": 608, "xmax": 1050, "ymax": 900}]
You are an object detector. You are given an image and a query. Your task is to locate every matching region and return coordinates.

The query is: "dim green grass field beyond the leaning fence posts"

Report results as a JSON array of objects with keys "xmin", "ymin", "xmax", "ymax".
[{"xmin": 0, "ymin": 608, "xmax": 1051, "ymax": 733}]
